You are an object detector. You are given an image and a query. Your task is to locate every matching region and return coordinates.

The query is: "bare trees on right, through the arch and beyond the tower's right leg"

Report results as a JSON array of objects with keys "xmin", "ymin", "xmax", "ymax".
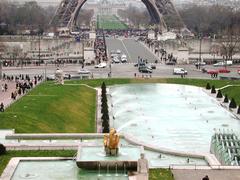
[{"xmin": 118, "ymin": 5, "xmax": 240, "ymax": 36}]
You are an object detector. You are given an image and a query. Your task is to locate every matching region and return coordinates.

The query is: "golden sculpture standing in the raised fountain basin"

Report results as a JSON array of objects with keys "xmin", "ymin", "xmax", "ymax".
[{"xmin": 103, "ymin": 128, "xmax": 119, "ymax": 156}]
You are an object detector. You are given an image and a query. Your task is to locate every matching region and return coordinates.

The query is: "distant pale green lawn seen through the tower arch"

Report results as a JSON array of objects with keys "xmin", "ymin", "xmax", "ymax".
[{"xmin": 97, "ymin": 15, "xmax": 128, "ymax": 30}]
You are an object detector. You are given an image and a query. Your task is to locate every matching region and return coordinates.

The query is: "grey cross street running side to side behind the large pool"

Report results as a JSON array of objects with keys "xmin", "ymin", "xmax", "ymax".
[{"xmin": 1, "ymin": 64, "xmax": 211, "ymax": 79}]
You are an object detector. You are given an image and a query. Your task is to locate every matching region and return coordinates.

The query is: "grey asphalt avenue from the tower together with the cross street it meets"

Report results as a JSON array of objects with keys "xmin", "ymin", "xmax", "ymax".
[{"xmin": 3, "ymin": 38, "xmax": 240, "ymax": 79}]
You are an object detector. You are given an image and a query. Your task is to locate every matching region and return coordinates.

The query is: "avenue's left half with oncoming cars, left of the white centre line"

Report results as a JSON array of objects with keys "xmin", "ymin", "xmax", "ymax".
[{"xmin": 106, "ymin": 38, "xmax": 131, "ymax": 60}]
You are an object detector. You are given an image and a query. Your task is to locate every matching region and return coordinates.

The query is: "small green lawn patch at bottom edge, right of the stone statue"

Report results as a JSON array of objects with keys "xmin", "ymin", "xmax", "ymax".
[{"xmin": 149, "ymin": 169, "xmax": 174, "ymax": 180}]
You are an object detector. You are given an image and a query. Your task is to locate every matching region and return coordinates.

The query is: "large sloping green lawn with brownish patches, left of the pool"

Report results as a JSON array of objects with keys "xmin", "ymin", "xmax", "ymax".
[{"xmin": 0, "ymin": 82, "xmax": 96, "ymax": 133}]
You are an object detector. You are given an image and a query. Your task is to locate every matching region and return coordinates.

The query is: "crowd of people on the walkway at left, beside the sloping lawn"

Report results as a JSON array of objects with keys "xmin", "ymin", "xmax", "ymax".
[{"xmin": 0, "ymin": 74, "xmax": 43, "ymax": 112}]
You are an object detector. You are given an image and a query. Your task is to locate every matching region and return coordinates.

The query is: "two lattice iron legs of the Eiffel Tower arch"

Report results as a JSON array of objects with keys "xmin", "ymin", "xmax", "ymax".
[{"xmin": 50, "ymin": 0, "xmax": 185, "ymax": 31}]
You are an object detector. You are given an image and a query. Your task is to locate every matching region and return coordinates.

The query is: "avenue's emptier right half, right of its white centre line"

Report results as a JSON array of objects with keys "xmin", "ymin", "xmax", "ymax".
[{"xmin": 122, "ymin": 39, "xmax": 157, "ymax": 63}]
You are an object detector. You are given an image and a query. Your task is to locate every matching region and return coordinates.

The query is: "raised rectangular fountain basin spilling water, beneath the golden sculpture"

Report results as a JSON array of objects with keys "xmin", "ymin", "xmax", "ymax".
[{"xmin": 76, "ymin": 146, "xmax": 143, "ymax": 170}]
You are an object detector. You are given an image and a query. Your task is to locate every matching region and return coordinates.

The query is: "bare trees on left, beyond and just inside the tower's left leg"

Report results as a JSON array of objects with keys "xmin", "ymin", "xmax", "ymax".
[{"xmin": 0, "ymin": 0, "xmax": 93, "ymax": 35}]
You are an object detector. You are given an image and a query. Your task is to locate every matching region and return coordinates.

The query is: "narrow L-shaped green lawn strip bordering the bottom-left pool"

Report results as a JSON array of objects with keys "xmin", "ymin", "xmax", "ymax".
[{"xmin": 0, "ymin": 150, "xmax": 76, "ymax": 176}]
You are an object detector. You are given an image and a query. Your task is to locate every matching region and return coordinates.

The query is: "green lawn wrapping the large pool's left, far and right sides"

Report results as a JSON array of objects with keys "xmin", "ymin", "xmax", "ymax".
[{"xmin": 0, "ymin": 79, "xmax": 240, "ymax": 133}]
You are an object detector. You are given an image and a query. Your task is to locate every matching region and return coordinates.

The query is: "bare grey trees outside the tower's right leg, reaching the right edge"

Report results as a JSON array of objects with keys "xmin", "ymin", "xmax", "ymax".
[{"xmin": 179, "ymin": 5, "xmax": 240, "ymax": 36}]
